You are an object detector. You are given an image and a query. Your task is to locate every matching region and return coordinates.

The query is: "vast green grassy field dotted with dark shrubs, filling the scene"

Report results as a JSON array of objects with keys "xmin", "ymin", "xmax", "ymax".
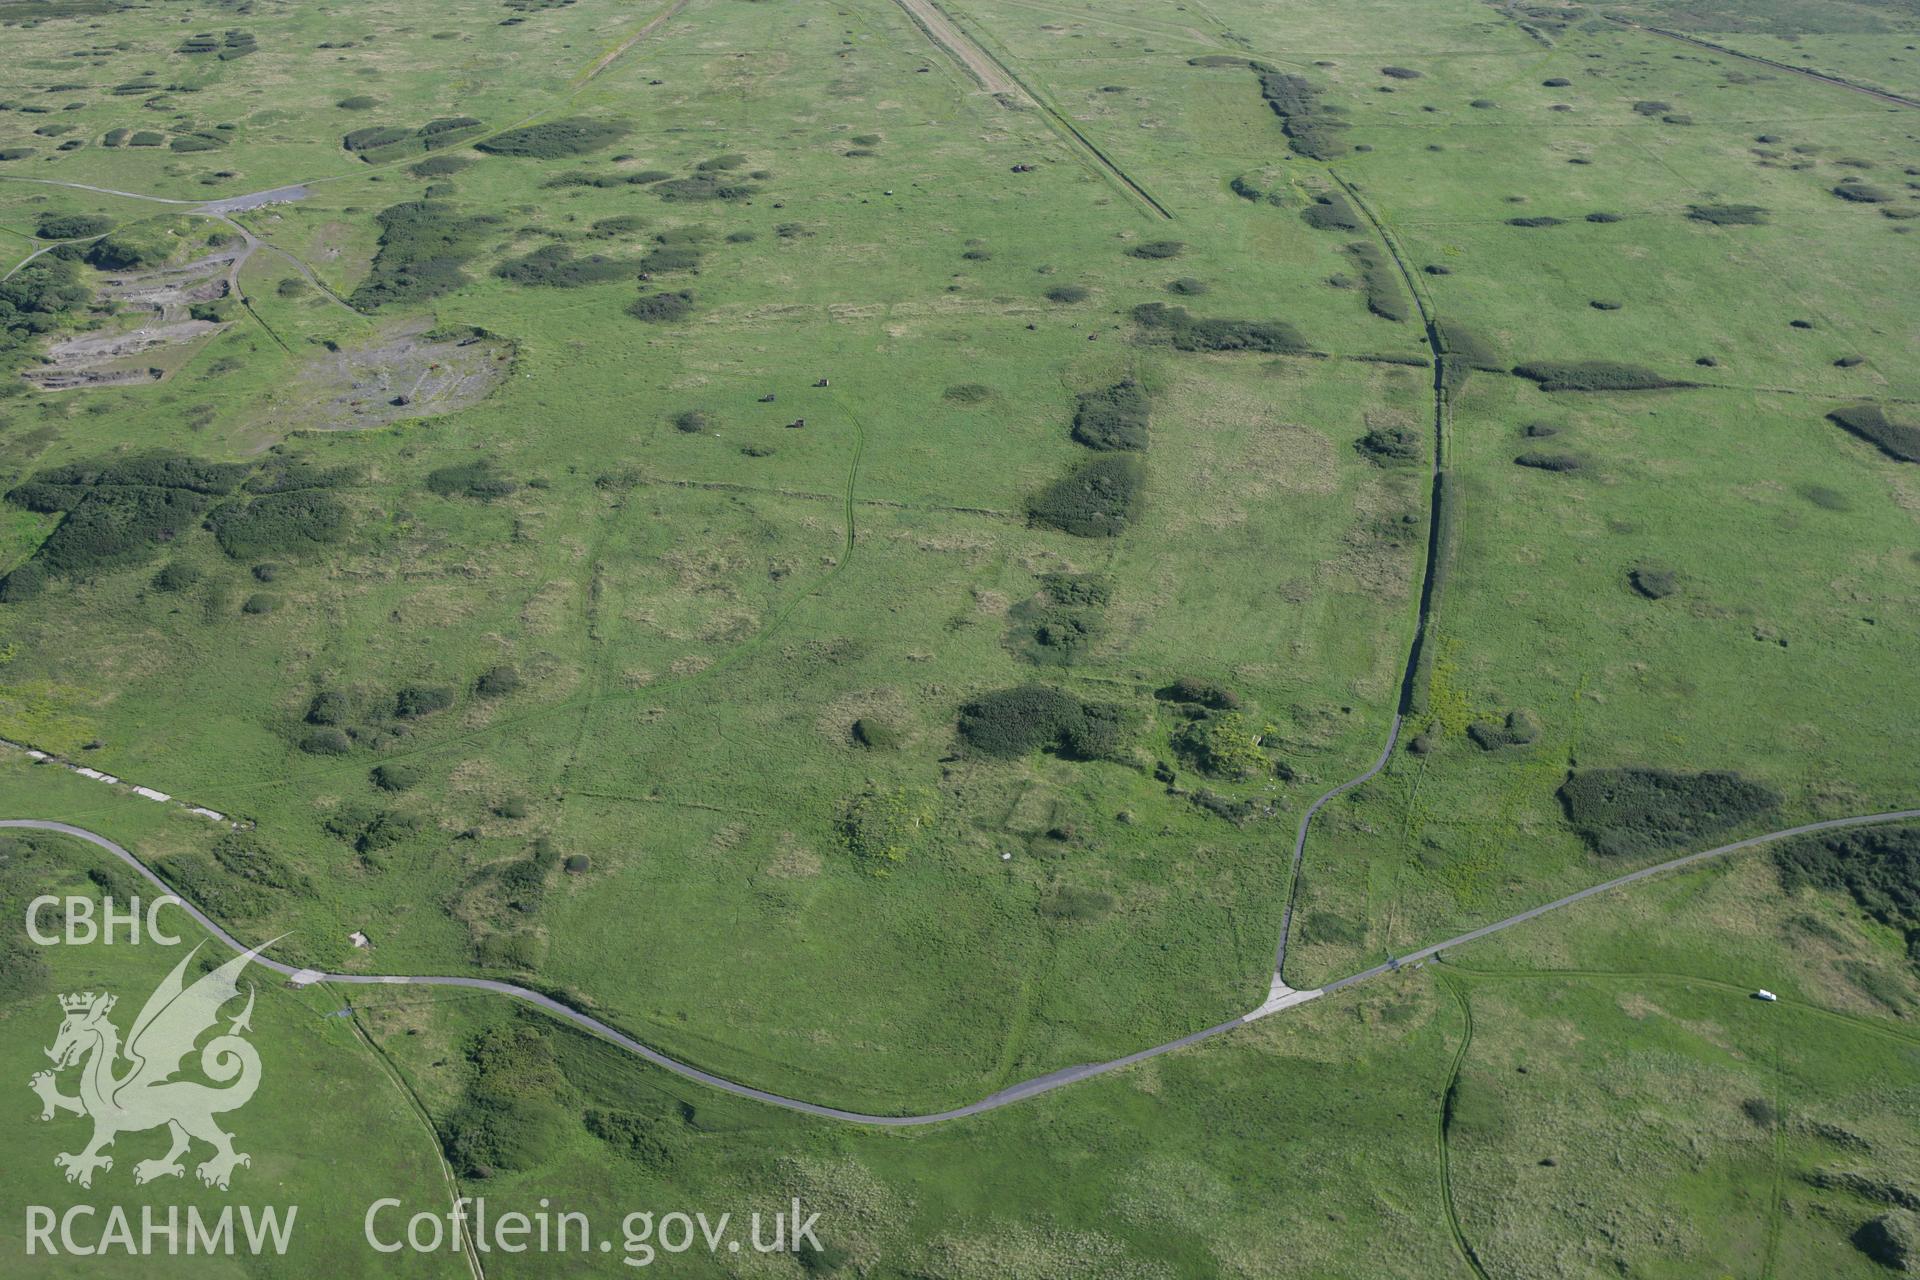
[{"xmin": 0, "ymin": 0, "xmax": 1920, "ymax": 1276}]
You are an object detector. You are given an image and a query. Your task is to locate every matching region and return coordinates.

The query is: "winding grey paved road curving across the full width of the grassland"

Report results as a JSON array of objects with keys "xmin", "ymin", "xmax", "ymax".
[{"xmin": 0, "ymin": 805, "xmax": 1920, "ymax": 1126}]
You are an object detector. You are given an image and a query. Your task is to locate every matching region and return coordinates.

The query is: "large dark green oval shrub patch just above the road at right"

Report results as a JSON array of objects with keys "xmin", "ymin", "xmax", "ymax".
[{"xmin": 1559, "ymin": 768, "xmax": 1780, "ymax": 856}]
